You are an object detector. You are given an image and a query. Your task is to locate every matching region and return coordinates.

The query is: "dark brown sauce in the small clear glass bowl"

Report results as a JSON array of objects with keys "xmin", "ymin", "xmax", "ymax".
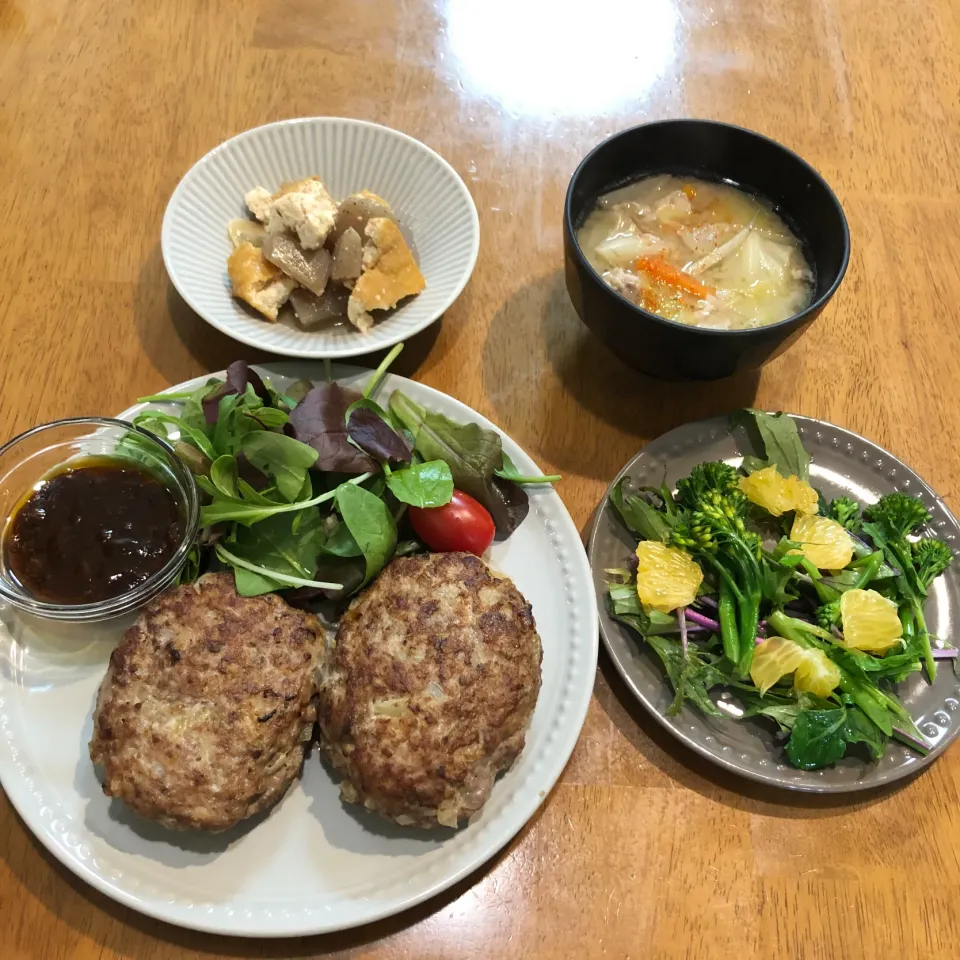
[{"xmin": 3, "ymin": 457, "xmax": 184, "ymax": 604}]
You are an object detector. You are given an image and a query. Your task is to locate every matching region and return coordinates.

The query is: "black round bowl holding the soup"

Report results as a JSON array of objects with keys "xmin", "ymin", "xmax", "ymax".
[{"xmin": 563, "ymin": 120, "xmax": 850, "ymax": 380}]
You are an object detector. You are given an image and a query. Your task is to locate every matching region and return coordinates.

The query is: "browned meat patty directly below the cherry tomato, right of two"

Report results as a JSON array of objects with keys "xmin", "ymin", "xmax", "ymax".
[{"xmin": 319, "ymin": 553, "xmax": 541, "ymax": 827}]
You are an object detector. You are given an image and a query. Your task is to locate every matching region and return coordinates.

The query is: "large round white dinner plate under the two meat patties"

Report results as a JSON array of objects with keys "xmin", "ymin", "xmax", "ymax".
[{"xmin": 0, "ymin": 363, "xmax": 598, "ymax": 937}]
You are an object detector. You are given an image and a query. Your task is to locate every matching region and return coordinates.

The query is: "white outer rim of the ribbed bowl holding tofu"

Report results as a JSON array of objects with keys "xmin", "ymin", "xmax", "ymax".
[{"xmin": 160, "ymin": 116, "xmax": 480, "ymax": 360}]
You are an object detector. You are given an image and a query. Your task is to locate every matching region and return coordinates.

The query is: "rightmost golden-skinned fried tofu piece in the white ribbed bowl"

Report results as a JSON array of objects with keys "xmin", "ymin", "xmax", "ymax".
[{"xmin": 347, "ymin": 217, "xmax": 427, "ymax": 333}]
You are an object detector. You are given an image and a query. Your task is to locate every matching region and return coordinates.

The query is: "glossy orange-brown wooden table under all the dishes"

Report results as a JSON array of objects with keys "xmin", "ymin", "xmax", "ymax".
[{"xmin": 0, "ymin": 0, "xmax": 960, "ymax": 960}]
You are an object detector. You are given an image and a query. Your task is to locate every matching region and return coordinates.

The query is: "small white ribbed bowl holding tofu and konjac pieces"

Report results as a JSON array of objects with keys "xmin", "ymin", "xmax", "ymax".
[{"xmin": 160, "ymin": 117, "xmax": 488, "ymax": 359}]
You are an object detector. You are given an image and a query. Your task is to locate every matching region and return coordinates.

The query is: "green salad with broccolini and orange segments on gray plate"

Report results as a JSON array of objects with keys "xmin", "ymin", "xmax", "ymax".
[{"xmin": 607, "ymin": 410, "xmax": 957, "ymax": 770}]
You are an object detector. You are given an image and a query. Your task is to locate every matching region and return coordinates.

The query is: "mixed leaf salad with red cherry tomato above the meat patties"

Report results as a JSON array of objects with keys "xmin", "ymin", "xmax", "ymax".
[{"xmin": 125, "ymin": 345, "xmax": 558, "ymax": 600}]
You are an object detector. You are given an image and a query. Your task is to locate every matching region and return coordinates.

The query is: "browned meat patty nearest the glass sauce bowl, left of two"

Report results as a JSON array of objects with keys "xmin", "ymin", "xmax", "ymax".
[{"xmin": 90, "ymin": 573, "xmax": 323, "ymax": 831}]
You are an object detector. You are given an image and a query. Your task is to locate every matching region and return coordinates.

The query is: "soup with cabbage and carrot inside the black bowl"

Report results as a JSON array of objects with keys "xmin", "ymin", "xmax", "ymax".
[{"xmin": 577, "ymin": 174, "xmax": 814, "ymax": 330}]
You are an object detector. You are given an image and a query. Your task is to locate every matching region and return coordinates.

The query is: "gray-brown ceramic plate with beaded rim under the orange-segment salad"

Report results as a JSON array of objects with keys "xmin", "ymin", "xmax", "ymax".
[{"xmin": 589, "ymin": 417, "xmax": 960, "ymax": 793}]
